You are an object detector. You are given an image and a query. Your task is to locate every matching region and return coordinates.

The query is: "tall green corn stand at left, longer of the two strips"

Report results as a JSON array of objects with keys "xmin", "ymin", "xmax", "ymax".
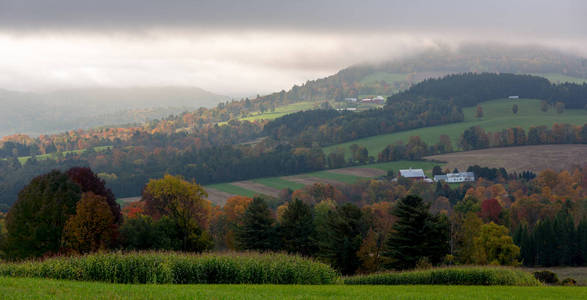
[{"xmin": 0, "ymin": 252, "xmax": 338, "ymax": 284}]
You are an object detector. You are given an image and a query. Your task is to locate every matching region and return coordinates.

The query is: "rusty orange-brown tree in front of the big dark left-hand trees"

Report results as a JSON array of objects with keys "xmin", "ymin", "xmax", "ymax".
[{"xmin": 63, "ymin": 192, "xmax": 117, "ymax": 253}]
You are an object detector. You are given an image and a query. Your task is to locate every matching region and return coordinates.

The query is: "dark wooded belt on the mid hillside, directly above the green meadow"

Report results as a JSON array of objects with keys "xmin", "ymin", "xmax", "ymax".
[{"xmin": 263, "ymin": 99, "xmax": 464, "ymax": 146}]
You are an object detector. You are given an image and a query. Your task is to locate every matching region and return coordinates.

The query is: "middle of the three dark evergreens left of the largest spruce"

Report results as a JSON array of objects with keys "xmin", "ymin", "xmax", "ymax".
[{"xmin": 279, "ymin": 199, "xmax": 316, "ymax": 256}]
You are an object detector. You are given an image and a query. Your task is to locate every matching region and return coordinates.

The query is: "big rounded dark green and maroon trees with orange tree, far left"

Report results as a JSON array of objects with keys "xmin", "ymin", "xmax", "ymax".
[{"xmin": 1, "ymin": 168, "xmax": 122, "ymax": 259}]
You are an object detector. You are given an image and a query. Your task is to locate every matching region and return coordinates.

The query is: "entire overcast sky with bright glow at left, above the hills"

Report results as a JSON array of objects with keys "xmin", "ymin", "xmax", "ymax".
[{"xmin": 0, "ymin": 0, "xmax": 587, "ymax": 97}]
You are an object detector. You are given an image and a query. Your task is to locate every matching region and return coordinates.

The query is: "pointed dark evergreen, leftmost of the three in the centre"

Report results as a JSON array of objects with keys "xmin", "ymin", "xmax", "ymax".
[{"xmin": 237, "ymin": 197, "xmax": 278, "ymax": 251}]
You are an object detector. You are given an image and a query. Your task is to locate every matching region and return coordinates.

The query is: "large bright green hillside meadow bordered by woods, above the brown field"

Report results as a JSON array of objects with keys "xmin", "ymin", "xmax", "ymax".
[{"xmin": 324, "ymin": 99, "xmax": 587, "ymax": 158}]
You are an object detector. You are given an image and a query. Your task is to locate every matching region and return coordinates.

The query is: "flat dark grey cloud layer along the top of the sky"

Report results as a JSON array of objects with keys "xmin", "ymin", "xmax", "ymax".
[{"xmin": 0, "ymin": 0, "xmax": 587, "ymax": 36}]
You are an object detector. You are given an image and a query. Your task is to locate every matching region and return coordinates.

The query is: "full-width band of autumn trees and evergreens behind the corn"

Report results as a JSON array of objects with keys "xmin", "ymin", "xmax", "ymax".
[{"xmin": 0, "ymin": 167, "xmax": 587, "ymax": 274}]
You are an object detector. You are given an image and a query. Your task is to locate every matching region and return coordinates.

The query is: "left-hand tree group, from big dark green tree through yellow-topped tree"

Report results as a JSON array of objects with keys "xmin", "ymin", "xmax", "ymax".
[{"xmin": 0, "ymin": 171, "xmax": 213, "ymax": 260}]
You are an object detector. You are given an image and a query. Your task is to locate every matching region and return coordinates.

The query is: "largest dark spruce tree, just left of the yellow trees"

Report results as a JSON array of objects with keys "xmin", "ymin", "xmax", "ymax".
[{"xmin": 383, "ymin": 195, "xmax": 449, "ymax": 270}]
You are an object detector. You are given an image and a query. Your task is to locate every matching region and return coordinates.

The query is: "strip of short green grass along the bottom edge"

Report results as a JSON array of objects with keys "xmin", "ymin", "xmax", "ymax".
[{"xmin": 0, "ymin": 277, "xmax": 587, "ymax": 300}]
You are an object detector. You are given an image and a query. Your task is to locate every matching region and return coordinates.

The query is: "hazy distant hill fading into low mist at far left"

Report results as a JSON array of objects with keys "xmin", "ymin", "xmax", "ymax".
[{"xmin": 0, "ymin": 87, "xmax": 229, "ymax": 136}]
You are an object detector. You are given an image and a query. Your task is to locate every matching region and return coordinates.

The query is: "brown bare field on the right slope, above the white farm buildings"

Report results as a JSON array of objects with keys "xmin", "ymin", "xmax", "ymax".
[{"xmin": 425, "ymin": 145, "xmax": 587, "ymax": 172}]
